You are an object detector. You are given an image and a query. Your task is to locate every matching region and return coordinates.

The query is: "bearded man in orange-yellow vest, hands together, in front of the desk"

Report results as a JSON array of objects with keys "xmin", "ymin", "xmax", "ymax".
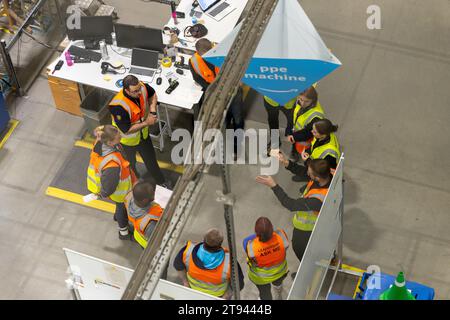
[{"xmin": 109, "ymin": 75, "xmax": 166, "ymax": 185}]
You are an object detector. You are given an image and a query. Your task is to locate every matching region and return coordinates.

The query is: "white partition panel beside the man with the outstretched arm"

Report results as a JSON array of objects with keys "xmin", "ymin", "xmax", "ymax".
[{"xmin": 288, "ymin": 156, "xmax": 344, "ymax": 300}]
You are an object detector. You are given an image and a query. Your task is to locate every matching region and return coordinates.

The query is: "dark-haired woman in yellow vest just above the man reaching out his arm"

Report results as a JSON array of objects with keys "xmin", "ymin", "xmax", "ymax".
[{"xmin": 302, "ymin": 119, "xmax": 341, "ymax": 169}]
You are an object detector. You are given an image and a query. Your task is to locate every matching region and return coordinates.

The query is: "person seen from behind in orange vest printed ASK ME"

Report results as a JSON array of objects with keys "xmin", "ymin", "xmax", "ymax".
[{"xmin": 243, "ymin": 217, "xmax": 289, "ymax": 300}]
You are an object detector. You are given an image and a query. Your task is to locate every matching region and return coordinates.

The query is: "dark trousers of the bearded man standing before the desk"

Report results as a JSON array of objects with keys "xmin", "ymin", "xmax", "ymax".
[{"xmin": 122, "ymin": 137, "xmax": 165, "ymax": 184}]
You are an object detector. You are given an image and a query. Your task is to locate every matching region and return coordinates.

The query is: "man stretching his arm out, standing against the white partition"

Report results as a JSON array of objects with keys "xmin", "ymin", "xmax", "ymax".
[{"xmin": 256, "ymin": 159, "xmax": 333, "ymax": 276}]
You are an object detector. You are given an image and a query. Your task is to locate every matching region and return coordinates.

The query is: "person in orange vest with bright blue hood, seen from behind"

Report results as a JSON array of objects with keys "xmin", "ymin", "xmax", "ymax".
[{"xmin": 173, "ymin": 228, "xmax": 244, "ymax": 299}]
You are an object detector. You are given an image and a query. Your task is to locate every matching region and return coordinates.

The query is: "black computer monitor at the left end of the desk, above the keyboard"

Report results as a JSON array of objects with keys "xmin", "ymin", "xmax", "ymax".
[{"xmin": 67, "ymin": 16, "xmax": 114, "ymax": 44}]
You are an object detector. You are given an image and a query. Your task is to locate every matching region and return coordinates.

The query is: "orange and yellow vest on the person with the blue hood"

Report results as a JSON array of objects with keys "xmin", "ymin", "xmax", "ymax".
[{"xmin": 183, "ymin": 241, "xmax": 231, "ymax": 297}]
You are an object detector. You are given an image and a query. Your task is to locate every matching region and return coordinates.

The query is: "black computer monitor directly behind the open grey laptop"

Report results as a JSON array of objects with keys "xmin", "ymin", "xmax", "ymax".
[{"xmin": 114, "ymin": 23, "xmax": 164, "ymax": 52}]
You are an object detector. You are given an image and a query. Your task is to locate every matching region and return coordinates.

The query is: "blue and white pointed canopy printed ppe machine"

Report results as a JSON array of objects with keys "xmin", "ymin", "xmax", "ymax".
[{"xmin": 203, "ymin": 0, "xmax": 341, "ymax": 105}]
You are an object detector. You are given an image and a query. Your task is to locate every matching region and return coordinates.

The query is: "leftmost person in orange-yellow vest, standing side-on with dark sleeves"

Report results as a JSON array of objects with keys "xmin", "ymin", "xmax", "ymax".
[{"xmin": 87, "ymin": 125, "xmax": 136, "ymax": 240}]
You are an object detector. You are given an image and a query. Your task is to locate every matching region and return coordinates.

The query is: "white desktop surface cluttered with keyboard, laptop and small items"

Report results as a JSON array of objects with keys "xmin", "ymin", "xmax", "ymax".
[{"xmin": 47, "ymin": 42, "xmax": 203, "ymax": 110}]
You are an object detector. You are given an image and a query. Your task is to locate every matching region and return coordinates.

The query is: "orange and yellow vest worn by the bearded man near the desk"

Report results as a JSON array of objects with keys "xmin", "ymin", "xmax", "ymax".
[{"xmin": 109, "ymin": 82, "xmax": 149, "ymax": 146}]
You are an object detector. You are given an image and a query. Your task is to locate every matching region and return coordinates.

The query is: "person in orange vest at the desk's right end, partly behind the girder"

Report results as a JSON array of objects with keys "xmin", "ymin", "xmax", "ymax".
[{"xmin": 189, "ymin": 38, "xmax": 245, "ymax": 157}]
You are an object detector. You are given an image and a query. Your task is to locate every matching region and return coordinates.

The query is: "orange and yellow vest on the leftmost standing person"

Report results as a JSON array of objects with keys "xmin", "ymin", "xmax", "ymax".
[{"xmin": 87, "ymin": 147, "xmax": 133, "ymax": 203}]
